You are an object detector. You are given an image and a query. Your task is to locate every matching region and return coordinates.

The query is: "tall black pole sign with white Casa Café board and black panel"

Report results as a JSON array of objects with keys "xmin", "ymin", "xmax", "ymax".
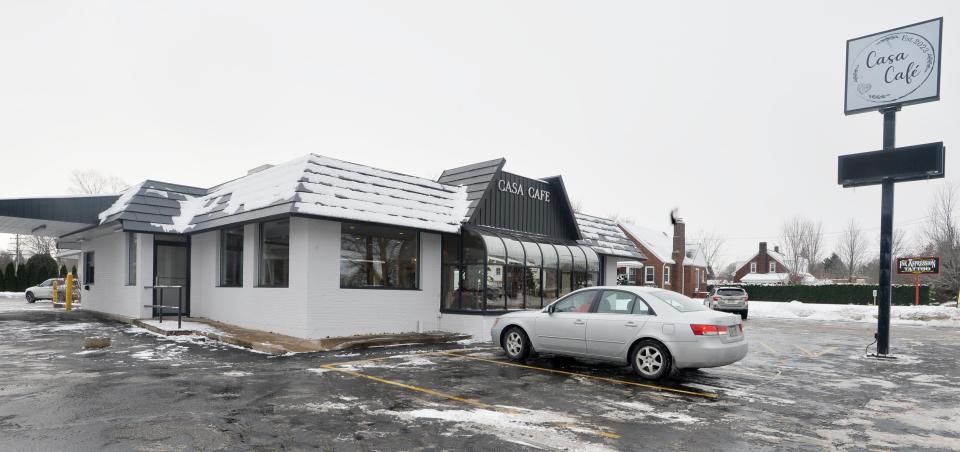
[{"xmin": 837, "ymin": 18, "xmax": 945, "ymax": 358}]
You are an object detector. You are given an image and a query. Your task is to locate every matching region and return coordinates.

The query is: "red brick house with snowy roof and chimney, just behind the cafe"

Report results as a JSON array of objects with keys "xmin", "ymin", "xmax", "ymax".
[{"xmin": 617, "ymin": 219, "xmax": 707, "ymax": 297}]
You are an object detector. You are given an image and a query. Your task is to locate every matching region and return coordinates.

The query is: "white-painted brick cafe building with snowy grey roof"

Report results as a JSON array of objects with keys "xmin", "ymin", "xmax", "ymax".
[{"xmin": 0, "ymin": 155, "xmax": 644, "ymax": 339}]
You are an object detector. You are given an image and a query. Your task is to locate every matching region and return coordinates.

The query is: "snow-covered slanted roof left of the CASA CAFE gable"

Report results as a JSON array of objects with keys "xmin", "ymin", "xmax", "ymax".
[{"xmin": 107, "ymin": 154, "xmax": 468, "ymax": 233}]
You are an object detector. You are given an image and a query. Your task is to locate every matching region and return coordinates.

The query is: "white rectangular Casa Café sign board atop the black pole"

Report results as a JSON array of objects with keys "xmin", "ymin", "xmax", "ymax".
[{"xmin": 844, "ymin": 17, "xmax": 943, "ymax": 115}]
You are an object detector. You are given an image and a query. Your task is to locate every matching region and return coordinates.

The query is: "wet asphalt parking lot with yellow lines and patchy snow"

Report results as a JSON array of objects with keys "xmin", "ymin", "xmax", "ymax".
[{"xmin": 0, "ymin": 300, "xmax": 960, "ymax": 451}]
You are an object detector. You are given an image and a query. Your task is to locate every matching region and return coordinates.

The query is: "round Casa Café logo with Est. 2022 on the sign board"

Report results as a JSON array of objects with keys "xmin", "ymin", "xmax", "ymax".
[{"xmin": 851, "ymin": 32, "xmax": 937, "ymax": 104}]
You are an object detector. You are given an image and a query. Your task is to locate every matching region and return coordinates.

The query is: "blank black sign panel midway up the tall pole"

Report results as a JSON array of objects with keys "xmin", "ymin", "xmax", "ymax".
[{"xmin": 837, "ymin": 142, "xmax": 945, "ymax": 187}]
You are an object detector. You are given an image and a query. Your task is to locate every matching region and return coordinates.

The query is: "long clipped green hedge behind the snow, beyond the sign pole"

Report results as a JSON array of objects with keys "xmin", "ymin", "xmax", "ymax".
[{"xmin": 712, "ymin": 284, "xmax": 930, "ymax": 305}]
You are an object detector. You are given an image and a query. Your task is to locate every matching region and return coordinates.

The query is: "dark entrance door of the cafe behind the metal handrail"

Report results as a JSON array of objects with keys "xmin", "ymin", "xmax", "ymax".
[{"xmin": 153, "ymin": 237, "xmax": 190, "ymax": 316}]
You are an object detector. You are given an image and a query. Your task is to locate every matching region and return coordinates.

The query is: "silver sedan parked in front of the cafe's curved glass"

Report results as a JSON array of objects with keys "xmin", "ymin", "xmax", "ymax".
[{"xmin": 490, "ymin": 286, "xmax": 747, "ymax": 380}]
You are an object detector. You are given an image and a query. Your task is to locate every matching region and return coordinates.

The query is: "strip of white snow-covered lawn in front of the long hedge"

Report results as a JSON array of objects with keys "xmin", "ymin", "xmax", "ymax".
[{"xmin": 750, "ymin": 300, "xmax": 960, "ymax": 327}]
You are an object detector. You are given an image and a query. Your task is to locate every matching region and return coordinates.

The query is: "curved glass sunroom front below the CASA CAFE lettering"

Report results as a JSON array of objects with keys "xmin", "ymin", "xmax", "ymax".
[{"xmin": 441, "ymin": 229, "xmax": 600, "ymax": 312}]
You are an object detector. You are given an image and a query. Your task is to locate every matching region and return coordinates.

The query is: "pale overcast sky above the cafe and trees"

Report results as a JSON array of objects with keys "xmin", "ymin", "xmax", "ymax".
[{"xmin": 0, "ymin": 0, "xmax": 960, "ymax": 261}]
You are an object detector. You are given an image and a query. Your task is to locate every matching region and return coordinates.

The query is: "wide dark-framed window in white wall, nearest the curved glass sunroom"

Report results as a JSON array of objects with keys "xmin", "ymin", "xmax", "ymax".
[{"xmin": 340, "ymin": 223, "xmax": 420, "ymax": 289}]
